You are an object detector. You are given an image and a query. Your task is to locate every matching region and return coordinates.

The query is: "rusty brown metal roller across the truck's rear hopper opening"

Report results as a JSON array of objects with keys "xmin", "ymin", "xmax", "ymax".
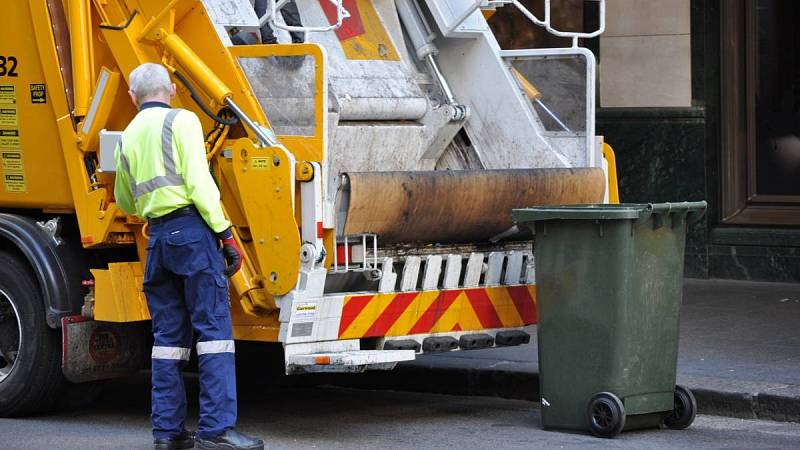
[{"xmin": 336, "ymin": 168, "xmax": 606, "ymax": 244}]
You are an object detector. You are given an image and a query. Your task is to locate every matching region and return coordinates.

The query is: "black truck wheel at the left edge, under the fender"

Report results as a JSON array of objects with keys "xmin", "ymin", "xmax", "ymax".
[{"xmin": 0, "ymin": 252, "xmax": 66, "ymax": 417}]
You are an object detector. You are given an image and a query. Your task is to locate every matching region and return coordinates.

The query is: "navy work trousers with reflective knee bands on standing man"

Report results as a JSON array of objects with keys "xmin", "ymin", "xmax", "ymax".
[{"xmin": 144, "ymin": 213, "xmax": 236, "ymax": 439}]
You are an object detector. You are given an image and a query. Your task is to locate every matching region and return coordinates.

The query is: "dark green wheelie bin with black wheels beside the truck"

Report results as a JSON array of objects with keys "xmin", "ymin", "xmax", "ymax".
[{"xmin": 513, "ymin": 201, "xmax": 706, "ymax": 437}]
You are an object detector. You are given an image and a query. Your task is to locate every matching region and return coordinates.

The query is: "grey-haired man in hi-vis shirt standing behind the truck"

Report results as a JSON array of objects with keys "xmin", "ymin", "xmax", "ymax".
[{"xmin": 114, "ymin": 63, "xmax": 264, "ymax": 449}]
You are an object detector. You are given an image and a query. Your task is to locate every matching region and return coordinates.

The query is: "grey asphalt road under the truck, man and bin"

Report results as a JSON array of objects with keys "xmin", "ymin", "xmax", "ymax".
[{"xmin": 0, "ymin": 375, "xmax": 800, "ymax": 450}]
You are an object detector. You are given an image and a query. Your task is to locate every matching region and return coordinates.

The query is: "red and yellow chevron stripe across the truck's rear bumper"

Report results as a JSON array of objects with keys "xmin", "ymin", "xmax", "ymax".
[{"xmin": 339, "ymin": 285, "xmax": 536, "ymax": 339}]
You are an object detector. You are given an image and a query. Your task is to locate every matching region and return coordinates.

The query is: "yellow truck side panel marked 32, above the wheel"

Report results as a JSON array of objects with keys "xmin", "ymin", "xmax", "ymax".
[{"xmin": 0, "ymin": 0, "xmax": 72, "ymax": 209}]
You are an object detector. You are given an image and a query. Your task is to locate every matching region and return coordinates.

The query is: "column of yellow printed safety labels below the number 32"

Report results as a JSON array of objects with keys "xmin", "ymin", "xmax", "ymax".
[{"xmin": 0, "ymin": 84, "xmax": 28, "ymax": 193}]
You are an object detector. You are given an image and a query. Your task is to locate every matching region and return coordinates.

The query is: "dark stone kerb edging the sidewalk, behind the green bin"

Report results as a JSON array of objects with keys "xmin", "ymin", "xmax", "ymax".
[{"xmin": 307, "ymin": 365, "xmax": 800, "ymax": 422}]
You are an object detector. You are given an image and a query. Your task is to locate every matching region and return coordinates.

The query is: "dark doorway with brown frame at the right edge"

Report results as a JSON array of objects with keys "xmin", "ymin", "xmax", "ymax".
[{"xmin": 720, "ymin": 0, "xmax": 800, "ymax": 225}]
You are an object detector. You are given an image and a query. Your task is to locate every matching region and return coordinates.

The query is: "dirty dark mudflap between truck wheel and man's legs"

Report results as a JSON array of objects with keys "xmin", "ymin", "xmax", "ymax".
[{"xmin": 61, "ymin": 316, "xmax": 149, "ymax": 383}]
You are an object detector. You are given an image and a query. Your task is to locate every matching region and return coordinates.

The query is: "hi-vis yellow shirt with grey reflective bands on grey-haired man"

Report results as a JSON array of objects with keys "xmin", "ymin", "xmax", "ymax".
[{"xmin": 114, "ymin": 102, "xmax": 230, "ymax": 233}]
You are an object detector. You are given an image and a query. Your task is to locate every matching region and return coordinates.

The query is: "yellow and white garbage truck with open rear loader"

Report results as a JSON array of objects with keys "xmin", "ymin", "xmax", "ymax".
[{"xmin": 0, "ymin": 0, "xmax": 616, "ymax": 416}]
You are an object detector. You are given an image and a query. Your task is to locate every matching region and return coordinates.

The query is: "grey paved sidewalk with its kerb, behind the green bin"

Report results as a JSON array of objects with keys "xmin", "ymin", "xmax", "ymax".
[{"xmin": 322, "ymin": 280, "xmax": 800, "ymax": 422}]
